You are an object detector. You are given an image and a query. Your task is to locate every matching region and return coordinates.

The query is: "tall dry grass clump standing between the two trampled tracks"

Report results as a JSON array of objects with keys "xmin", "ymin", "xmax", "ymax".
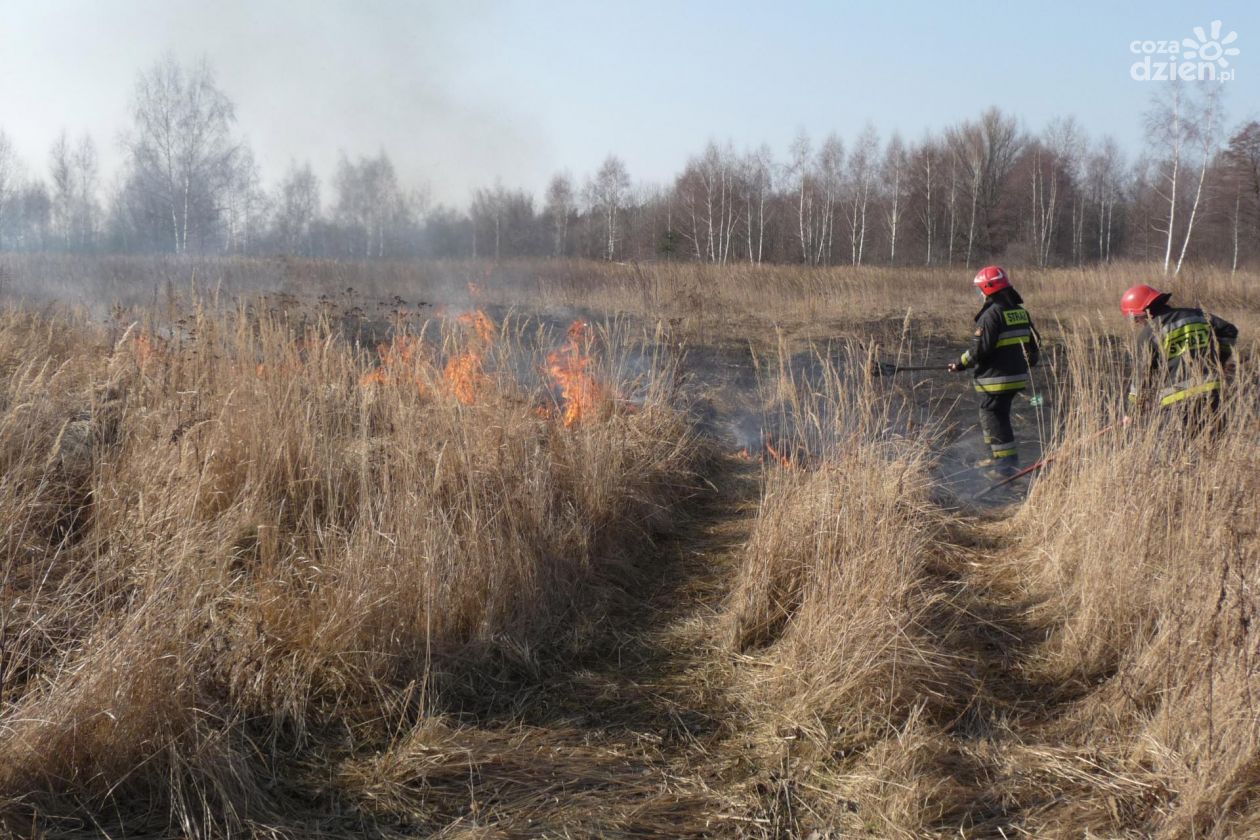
[{"xmin": 727, "ymin": 359, "xmax": 956, "ymax": 749}]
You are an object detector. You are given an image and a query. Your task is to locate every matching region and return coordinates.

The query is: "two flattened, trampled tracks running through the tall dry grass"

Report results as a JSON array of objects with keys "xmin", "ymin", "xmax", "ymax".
[{"xmin": 330, "ymin": 458, "xmax": 1123, "ymax": 840}]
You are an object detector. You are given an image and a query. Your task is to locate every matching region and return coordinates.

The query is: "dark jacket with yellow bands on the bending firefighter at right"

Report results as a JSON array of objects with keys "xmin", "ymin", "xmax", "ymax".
[{"xmin": 1129, "ymin": 306, "xmax": 1239, "ymax": 408}]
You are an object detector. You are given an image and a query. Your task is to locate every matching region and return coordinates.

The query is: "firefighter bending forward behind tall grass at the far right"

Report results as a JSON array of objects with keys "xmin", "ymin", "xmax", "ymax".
[{"xmin": 1120, "ymin": 283, "xmax": 1239, "ymax": 432}]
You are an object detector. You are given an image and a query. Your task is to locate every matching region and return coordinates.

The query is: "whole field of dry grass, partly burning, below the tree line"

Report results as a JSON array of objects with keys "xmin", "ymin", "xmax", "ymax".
[{"xmin": 0, "ymin": 257, "xmax": 1260, "ymax": 839}]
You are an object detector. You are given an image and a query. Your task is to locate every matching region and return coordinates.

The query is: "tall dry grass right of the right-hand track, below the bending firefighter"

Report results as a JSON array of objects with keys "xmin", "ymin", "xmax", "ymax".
[{"xmin": 995, "ymin": 329, "xmax": 1260, "ymax": 837}]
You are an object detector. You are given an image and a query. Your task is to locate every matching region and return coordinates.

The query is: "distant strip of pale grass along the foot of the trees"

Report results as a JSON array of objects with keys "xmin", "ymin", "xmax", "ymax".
[{"xmin": 14, "ymin": 254, "xmax": 1260, "ymax": 341}]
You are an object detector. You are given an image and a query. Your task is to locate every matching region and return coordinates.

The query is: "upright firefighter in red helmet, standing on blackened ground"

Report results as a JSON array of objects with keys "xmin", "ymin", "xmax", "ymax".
[{"xmin": 949, "ymin": 266, "xmax": 1040, "ymax": 479}]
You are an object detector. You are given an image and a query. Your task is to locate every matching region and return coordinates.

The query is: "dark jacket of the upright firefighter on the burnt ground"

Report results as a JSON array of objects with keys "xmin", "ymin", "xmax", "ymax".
[{"xmin": 959, "ymin": 288, "xmax": 1041, "ymax": 394}]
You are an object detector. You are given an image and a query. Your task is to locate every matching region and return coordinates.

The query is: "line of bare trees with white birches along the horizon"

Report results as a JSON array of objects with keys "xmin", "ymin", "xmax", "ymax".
[{"xmin": 0, "ymin": 57, "xmax": 1260, "ymax": 273}]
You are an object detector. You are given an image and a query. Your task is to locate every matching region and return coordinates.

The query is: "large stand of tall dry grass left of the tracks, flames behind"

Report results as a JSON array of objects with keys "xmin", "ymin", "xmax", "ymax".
[{"xmin": 0, "ymin": 300, "xmax": 703, "ymax": 836}]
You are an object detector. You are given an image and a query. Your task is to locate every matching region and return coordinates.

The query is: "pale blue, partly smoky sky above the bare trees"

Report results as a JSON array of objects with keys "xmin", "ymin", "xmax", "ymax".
[{"xmin": 0, "ymin": 0, "xmax": 1260, "ymax": 203}]
